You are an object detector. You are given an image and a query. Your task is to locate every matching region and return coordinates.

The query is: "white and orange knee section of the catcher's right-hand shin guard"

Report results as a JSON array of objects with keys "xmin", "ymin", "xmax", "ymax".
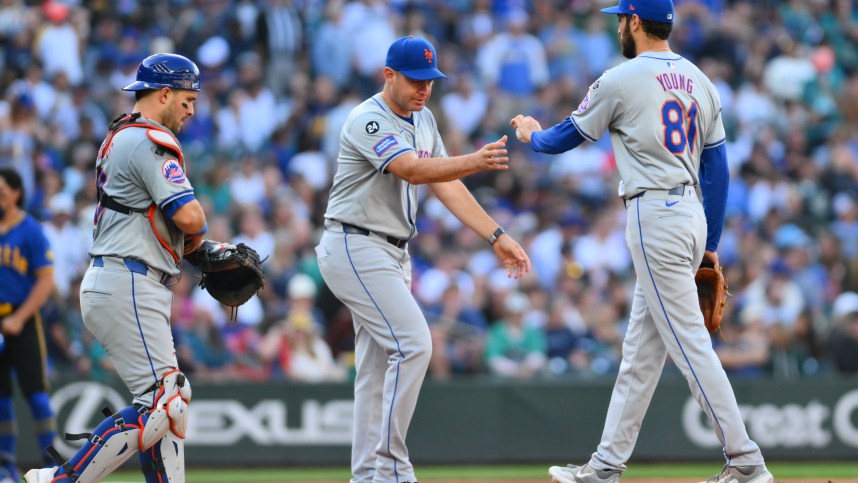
[{"xmin": 140, "ymin": 369, "xmax": 191, "ymax": 451}]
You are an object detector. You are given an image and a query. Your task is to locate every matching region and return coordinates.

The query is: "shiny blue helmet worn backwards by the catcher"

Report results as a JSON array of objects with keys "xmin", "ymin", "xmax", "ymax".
[{"xmin": 122, "ymin": 54, "xmax": 200, "ymax": 91}]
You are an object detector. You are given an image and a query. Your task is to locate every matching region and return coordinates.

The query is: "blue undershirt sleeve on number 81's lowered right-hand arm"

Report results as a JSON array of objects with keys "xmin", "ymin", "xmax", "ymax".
[{"xmin": 698, "ymin": 139, "xmax": 730, "ymax": 252}]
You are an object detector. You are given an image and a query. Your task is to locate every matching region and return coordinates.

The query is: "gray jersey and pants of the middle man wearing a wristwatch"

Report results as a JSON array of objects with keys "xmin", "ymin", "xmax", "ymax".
[{"xmin": 316, "ymin": 94, "xmax": 446, "ymax": 483}]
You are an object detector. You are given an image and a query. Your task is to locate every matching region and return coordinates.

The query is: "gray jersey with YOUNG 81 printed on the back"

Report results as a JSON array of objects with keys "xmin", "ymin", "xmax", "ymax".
[{"xmin": 570, "ymin": 52, "xmax": 725, "ymax": 198}]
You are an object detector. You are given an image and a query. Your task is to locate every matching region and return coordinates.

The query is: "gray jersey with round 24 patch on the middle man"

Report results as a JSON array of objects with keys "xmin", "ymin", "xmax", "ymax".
[{"xmin": 325, "ymin": 94, "xmax": 447, "ymax": 240}]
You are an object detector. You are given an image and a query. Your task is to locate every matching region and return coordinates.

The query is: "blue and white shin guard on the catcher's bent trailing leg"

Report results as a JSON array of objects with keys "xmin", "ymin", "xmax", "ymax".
[{"xmin": 49, "ymin": 406, "xmax": 146, "ymax": 483}]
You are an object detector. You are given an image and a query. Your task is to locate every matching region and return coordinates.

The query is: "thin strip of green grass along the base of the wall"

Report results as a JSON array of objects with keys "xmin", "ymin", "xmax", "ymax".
[{"xmin": 104, "ymin": 462, "xmax": 858, "ymax": 483}]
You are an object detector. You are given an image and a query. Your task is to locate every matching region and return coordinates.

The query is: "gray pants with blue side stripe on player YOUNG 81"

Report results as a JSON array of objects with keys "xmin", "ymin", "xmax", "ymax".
[{"xmin": 590, "ymin": 187, "xmax": 763, "ymax": 470}]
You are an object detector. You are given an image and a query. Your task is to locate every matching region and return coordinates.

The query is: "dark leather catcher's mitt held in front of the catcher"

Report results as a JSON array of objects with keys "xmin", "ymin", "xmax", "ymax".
[{"xmin": 185, "ymin": 240, "xmax": 265, "ymax": 307}]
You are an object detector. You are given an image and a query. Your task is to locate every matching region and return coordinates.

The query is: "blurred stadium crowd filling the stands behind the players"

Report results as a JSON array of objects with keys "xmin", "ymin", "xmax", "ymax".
[{"xmin": 0, "ymin": 0, "xmax": 858, "ymax": 382}]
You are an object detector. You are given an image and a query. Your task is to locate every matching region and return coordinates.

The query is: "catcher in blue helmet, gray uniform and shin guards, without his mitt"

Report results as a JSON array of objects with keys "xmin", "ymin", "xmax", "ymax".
[{"xmin": 24, "ymin": 53, "xmax": 206, "ymax": 483}]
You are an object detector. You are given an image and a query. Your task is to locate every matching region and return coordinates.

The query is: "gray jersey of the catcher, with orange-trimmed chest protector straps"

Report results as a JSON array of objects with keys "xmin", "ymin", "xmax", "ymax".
[{"xmin": 89, "ymin": 119, "xmax": 194, "ymax": 275}]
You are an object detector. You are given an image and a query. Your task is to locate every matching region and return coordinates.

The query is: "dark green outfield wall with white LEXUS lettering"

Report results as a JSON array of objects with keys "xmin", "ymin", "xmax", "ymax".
[{"xmin": 16, "ymin": 378, "xmax": 858, "ymax": 466}]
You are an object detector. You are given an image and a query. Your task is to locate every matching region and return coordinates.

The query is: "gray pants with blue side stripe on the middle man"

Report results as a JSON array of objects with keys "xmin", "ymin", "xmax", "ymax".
[{"xmin": 316, "ymin": 226, "xmax": 432, "ymax": 483}]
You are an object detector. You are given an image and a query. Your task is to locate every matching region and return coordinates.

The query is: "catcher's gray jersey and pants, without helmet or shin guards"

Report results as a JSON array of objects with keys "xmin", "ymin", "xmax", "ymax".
[{"xmin": 81, "ymin": 119, "xmax": 194, "ymax": 407}]
